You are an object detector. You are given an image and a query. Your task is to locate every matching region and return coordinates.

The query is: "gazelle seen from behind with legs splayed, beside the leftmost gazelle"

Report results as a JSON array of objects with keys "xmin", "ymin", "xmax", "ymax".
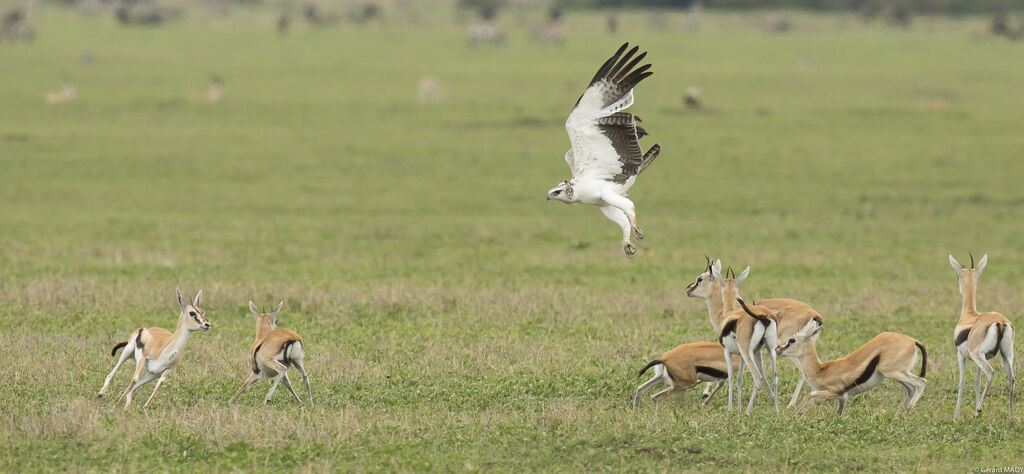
[{"xmin": 228, "ymin": 301, "xmax": 313, "ymax": 404}]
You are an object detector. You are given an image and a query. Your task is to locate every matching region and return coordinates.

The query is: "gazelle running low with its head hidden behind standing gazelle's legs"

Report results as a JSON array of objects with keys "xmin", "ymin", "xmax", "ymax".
[{"xmin": 633, "ymin": 342, "xmax": 741, "ymax": 410}]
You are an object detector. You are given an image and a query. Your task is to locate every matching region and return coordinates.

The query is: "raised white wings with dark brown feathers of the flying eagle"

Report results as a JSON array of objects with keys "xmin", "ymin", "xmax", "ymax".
[{"xmin": 565, "ymin": 43, "xmax": 660, "ymax": 184}]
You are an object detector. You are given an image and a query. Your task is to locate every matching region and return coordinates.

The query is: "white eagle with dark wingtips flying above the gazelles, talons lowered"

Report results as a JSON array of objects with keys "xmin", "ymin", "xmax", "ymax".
[{"xmin": 548, "ymin": 43, "xmax": 662, "ymax": 258}]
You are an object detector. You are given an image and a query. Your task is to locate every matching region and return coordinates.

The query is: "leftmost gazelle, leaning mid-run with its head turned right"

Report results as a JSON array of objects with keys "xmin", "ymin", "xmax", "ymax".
[{"xmin": 96, "ymin": 290, "xmax": 210, "ymax": 410}]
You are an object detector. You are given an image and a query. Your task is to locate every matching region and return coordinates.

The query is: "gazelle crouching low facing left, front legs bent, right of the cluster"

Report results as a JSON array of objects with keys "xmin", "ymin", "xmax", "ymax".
[{"xmin": 776, "ymin": 328, "xmax": 928, "ymax": 415}]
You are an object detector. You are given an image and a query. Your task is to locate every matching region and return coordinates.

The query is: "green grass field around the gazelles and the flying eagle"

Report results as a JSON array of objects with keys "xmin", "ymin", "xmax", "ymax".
[{"xmin": 0, "ymin": 9, "xmax": 1024, "ymax": 472}]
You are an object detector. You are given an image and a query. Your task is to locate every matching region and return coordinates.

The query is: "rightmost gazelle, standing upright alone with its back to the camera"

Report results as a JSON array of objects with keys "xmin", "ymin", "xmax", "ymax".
[{"xmin": 949, "ymin": 254, "xmax": 1014, "ymax": 420}]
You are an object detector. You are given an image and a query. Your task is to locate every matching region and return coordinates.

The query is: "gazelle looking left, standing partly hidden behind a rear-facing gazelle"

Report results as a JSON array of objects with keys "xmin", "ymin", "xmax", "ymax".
[{"xmin": 686, "ymin": 257, "xmax": 823, "ymax": 407}]
